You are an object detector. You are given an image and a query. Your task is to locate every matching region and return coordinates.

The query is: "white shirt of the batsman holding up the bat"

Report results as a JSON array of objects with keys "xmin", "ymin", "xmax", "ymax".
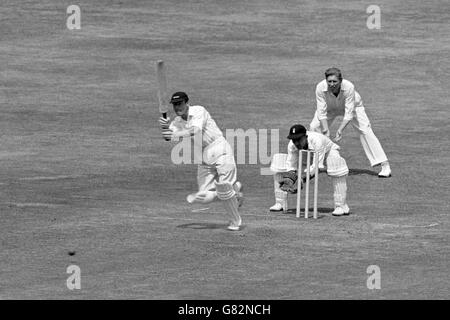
[{"xmin": 169, "ymin": 106, "xmax": 223, "ymax": 149}]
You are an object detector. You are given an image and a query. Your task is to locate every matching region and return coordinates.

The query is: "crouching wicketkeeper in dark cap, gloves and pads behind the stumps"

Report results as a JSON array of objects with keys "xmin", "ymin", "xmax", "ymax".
[{"xmin": 270, "ymin": 124, "xmax": 350, "ymax": 216}]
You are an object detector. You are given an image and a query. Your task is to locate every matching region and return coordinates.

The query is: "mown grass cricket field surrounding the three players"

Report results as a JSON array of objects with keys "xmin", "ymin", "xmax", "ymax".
[{"xmin": 0, "ymin": 0, "xmax": 450, "ymax": 299}]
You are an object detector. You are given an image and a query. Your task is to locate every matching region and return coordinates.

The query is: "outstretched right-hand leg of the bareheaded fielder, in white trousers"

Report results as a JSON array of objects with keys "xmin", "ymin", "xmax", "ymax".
[{"xmin": 352, "ymin": 103, "xmax": 391, "ymax": 178}]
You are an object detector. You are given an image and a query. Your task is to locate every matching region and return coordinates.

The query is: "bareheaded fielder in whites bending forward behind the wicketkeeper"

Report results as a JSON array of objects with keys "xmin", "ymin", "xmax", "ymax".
[{"xmin": 309, "ymin": 68, "xmax": 391, "ymax": 178}]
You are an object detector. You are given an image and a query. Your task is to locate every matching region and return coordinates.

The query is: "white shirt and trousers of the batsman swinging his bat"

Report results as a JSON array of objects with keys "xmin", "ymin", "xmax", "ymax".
[{"xmin": 169, "ymin": 105, "xmax": 236, "ymax": 191}]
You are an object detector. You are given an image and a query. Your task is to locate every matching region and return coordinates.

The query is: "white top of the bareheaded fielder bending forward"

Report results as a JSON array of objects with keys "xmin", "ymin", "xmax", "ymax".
[{"xmin": 316, "ymin": 79, "xmax": 363, "ymax": 120}]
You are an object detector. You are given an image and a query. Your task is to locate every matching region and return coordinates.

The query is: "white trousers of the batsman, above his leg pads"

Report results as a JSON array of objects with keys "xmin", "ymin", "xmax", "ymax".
[{"xmin": 197, "ymin": 137, "xmax": 237, "ymax": 191}]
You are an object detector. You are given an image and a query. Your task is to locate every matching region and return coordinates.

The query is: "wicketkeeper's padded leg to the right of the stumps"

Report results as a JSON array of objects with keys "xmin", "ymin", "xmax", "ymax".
[{"xmin": 327, "ymin": 149, "xmax": 350, "ymax": 216}]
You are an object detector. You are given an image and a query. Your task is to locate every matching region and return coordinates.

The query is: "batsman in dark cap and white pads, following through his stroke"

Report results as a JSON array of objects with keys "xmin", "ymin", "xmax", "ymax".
[{"xmin": 159, "ymin": 92, "xmax": 243, "ymax": 231}]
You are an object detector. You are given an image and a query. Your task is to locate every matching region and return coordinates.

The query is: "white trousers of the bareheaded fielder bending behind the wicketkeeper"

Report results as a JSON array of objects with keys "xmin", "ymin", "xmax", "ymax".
[{"xmin": 309, "ymin": 106, "xmax": 388, "ymax": 167}]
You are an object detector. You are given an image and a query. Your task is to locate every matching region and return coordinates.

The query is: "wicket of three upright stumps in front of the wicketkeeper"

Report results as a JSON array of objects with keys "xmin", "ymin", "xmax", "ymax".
[{"xmin": 296, "ymin": 150, "xmax": 319, "ymax": 219}]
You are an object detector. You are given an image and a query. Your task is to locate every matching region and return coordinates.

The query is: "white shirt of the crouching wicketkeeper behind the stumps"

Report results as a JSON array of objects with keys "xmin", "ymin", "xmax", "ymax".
[{"xmin": 286, "ymin": 131, "xmax": 340, "ymax": 171}]
